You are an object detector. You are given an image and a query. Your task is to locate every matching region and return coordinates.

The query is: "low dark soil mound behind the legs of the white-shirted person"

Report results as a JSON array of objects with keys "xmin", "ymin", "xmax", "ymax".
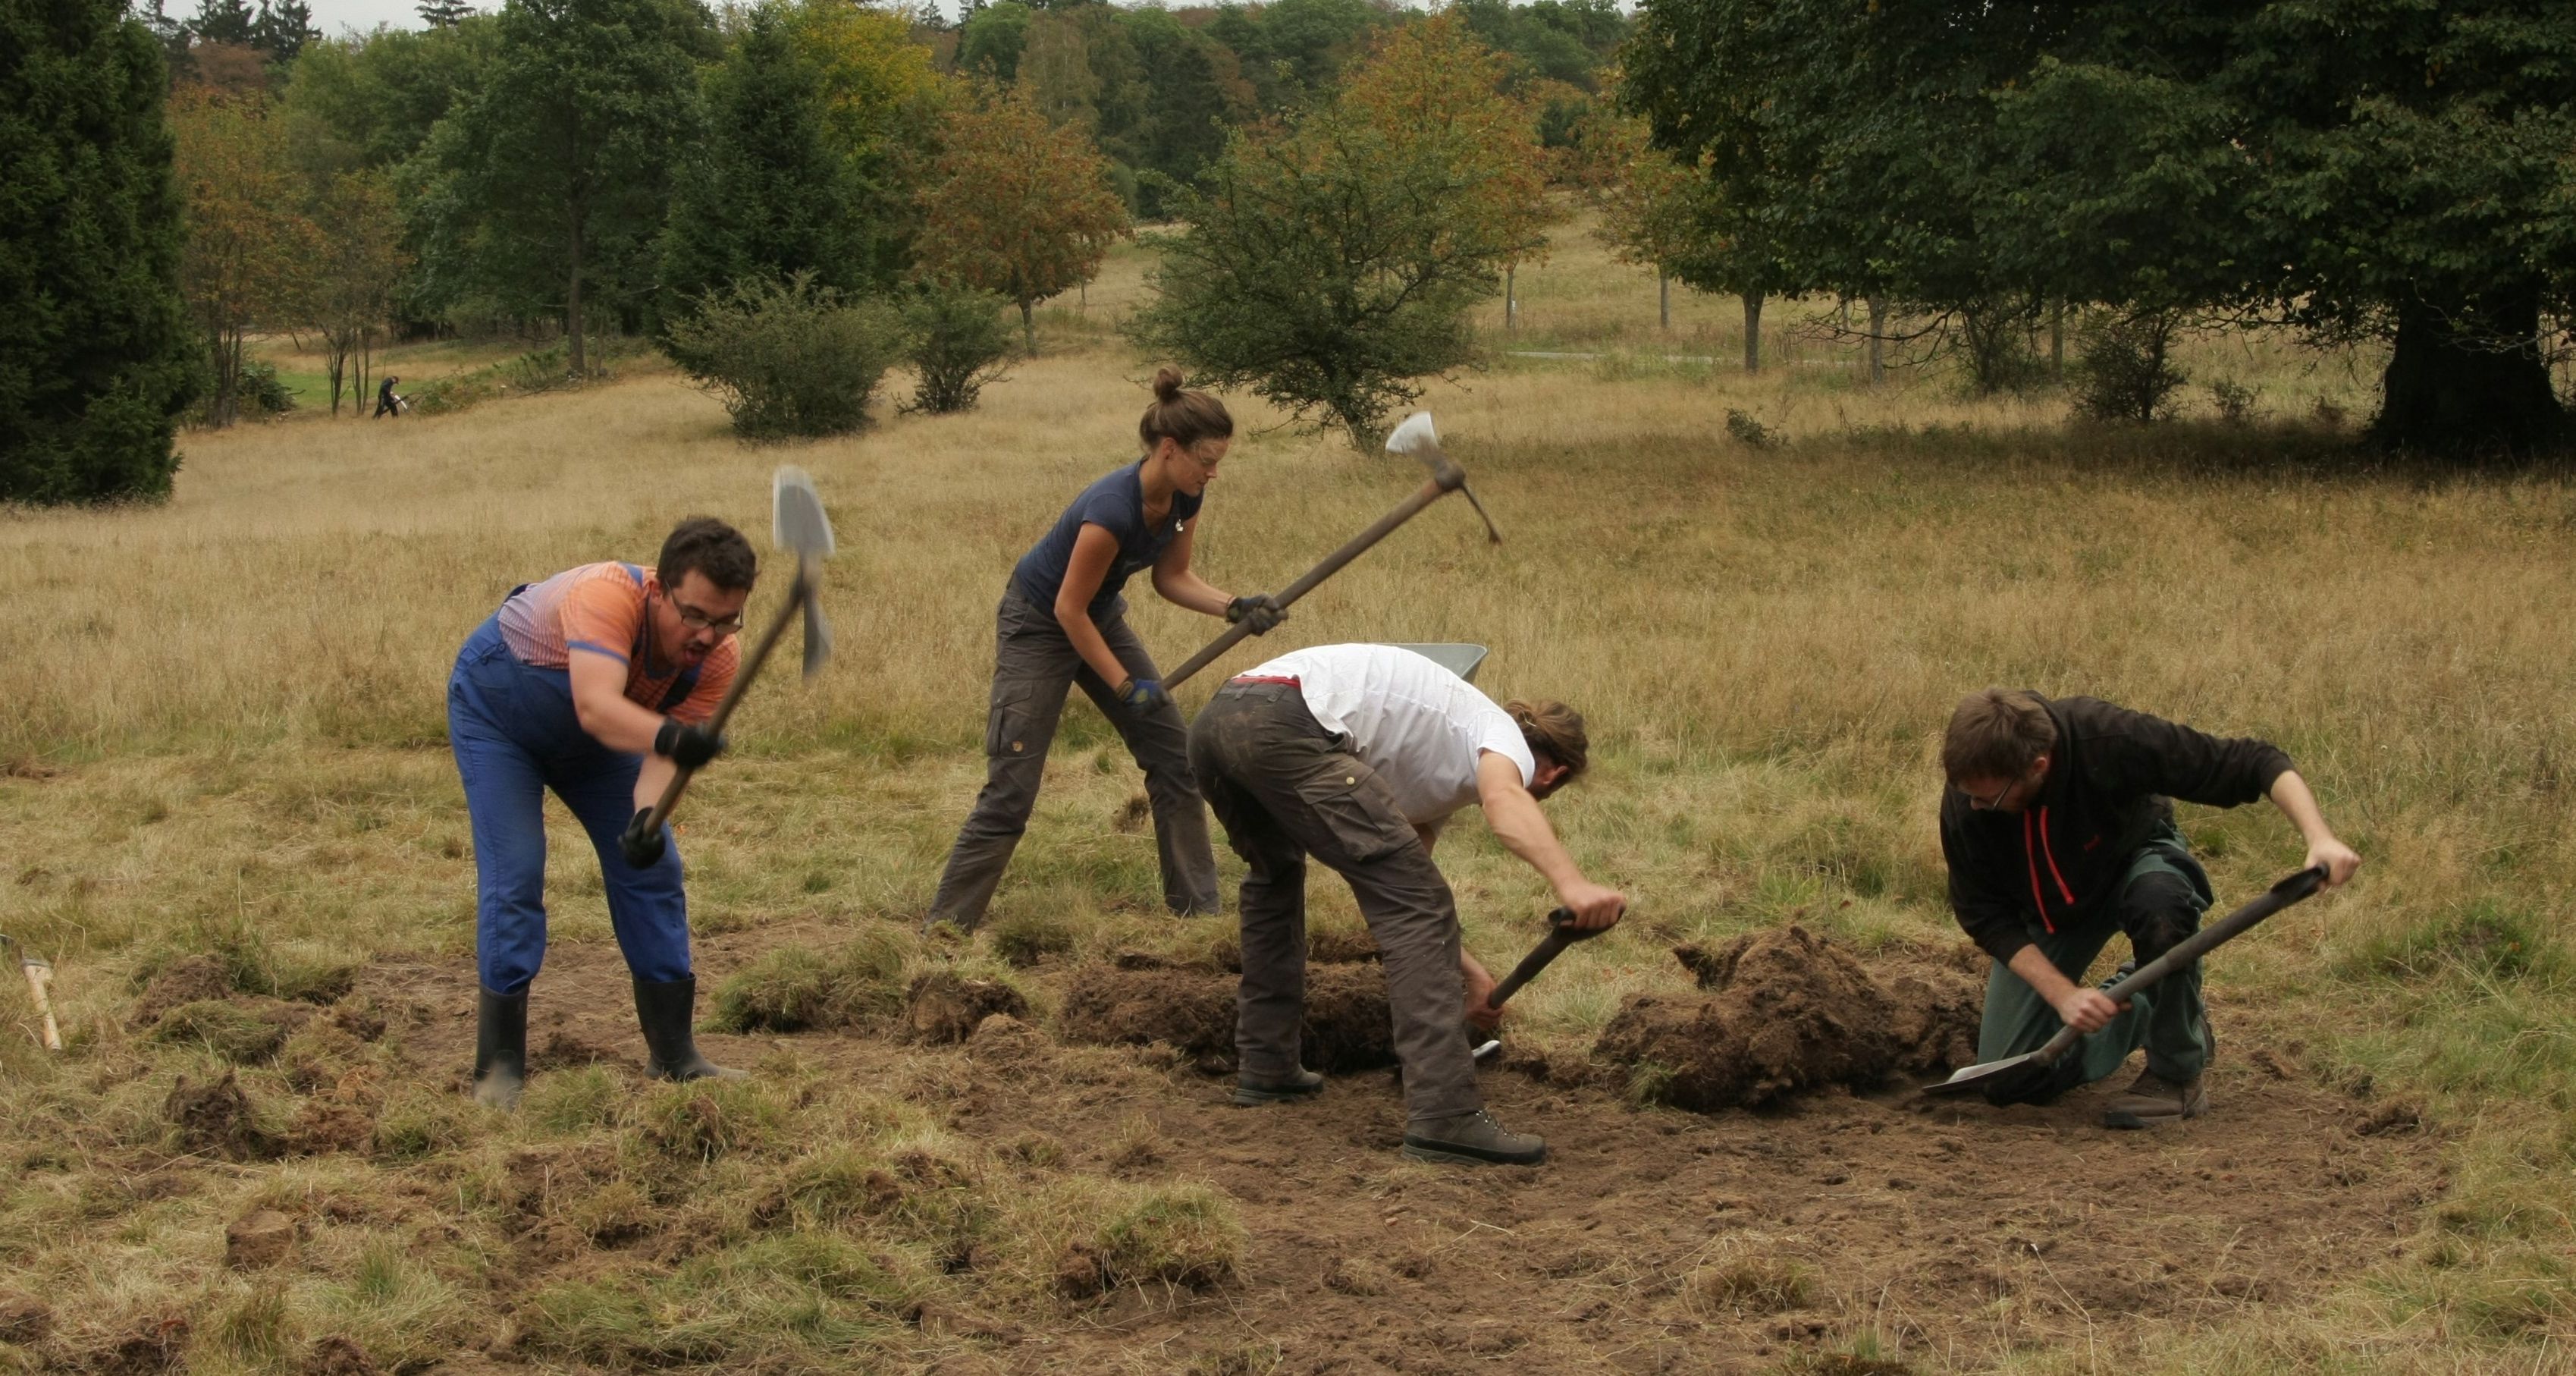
[{"xmin": 1056, "ymin": 963, "xmax": 1396, "ymax": 1072}]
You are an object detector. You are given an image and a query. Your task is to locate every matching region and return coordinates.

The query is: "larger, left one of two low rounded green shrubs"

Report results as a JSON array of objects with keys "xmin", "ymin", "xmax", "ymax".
[{"xmin": 664, "ymin": 273, "xmax": 902, "ymax": 441}]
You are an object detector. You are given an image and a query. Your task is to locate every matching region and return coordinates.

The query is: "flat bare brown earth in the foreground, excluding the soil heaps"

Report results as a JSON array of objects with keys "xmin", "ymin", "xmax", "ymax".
[{"xmin": 363, "ymin": 928, "xmax": 2440, "ymax": 1374}]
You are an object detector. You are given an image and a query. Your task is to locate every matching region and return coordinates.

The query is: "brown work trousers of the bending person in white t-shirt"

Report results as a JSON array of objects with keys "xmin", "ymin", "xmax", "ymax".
[{"xmin": 1190, "ymin": 683, "xmax": 1484, "ymax": 1123}]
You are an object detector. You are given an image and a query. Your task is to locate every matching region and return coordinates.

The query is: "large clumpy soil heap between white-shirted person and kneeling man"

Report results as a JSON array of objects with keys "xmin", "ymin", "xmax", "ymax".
[{"xmin": 1592, "ymin": 925, "xmax": 1978, "ymax": 1114}]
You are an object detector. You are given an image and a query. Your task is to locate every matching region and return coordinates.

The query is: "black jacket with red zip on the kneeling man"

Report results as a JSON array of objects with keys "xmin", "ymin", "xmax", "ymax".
[{"xmin": 1940, "ymin": 699, "xmax": 2290, "ymax": 963}]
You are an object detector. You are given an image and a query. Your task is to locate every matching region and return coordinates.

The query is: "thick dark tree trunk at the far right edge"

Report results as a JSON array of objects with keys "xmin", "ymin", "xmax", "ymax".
[{"xmin": 2370, "ymin": 286, "xmax": 2576, "ymax": 456}]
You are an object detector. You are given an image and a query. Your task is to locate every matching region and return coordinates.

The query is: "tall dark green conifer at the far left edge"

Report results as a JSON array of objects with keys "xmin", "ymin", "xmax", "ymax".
[{"xmin": 0, "ymin": 0, "xmax": 196, "ymax": 502}]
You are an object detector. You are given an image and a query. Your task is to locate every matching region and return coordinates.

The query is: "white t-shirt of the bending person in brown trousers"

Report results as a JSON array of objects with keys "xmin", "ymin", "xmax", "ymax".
[{"xmin": 1244, "ymin": 644, "xmax": 1538, "ymax": 827}]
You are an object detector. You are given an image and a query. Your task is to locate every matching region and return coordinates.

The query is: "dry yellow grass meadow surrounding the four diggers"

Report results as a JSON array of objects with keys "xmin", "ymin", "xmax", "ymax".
[{"xmin": 0, "ymin": 229, "xmax": 2576, "ymax": 1371}]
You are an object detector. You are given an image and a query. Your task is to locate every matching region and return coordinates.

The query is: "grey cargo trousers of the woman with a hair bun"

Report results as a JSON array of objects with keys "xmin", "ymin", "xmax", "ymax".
[{"xmin": 930, "ymin": 588, "xmax": 1216, "ymax": 930}]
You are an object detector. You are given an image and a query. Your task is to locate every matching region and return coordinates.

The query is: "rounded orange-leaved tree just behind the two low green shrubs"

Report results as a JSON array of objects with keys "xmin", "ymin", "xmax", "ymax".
[{"xmin": 917, "ymin": 90, "xmax": 1128, "ymax": 353}]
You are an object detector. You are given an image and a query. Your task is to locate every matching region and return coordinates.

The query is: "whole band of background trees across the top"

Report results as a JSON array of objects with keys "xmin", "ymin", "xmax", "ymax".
[{"xmin": 0, "ymin": 0, "xmax": 2576, "ymax": 500}]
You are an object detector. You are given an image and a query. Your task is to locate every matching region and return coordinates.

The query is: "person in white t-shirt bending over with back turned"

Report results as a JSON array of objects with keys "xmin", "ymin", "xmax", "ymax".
[{"xmin": 1190, "ymin": 644, "xmax": 1628, "ymax": 1164}]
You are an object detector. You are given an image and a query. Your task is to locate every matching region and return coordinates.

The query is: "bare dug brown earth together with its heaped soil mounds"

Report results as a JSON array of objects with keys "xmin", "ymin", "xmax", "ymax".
[{"xmin": 115, "ymin": 930, "xmax": 2440, "ymax": 1374}]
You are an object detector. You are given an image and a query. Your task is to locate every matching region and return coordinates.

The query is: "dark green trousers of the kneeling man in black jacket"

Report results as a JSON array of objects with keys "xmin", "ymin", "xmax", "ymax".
[{"xmin": 1975, "ymin": 827, "xmax": 2210, "ymax": 1101}]
